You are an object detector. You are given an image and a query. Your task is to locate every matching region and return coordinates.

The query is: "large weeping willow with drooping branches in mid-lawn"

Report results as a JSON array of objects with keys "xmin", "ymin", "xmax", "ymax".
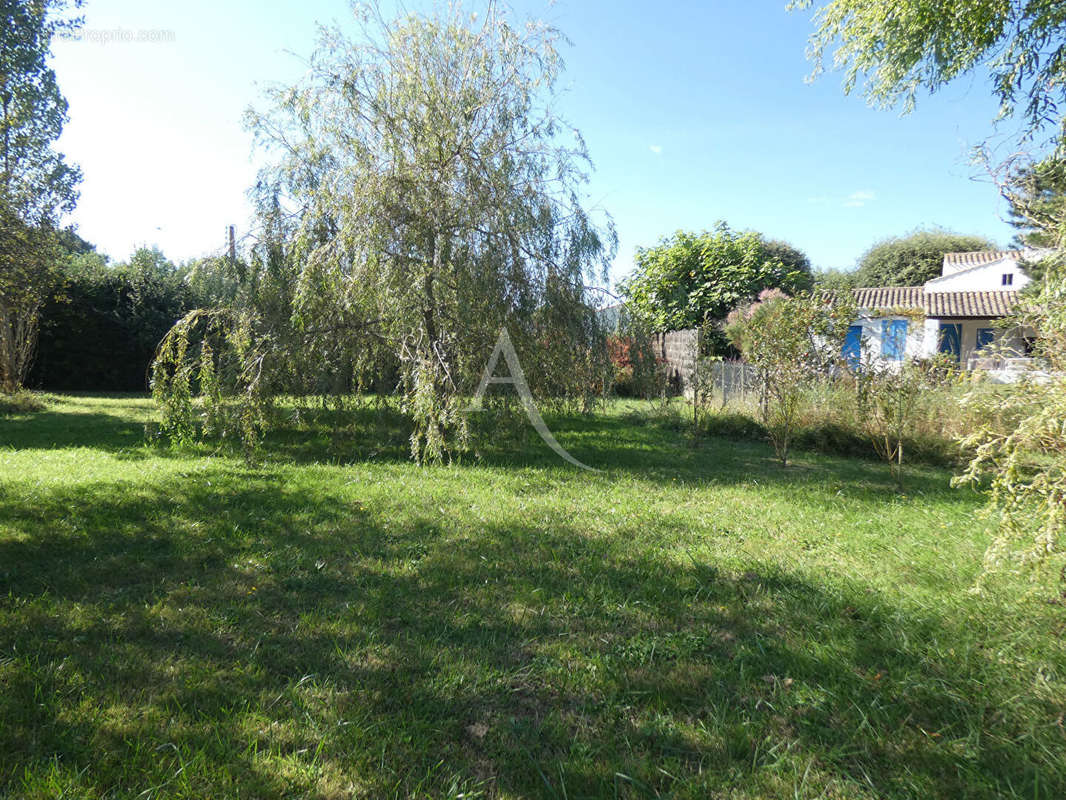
[{"xmin": 154, "ymin": 4, "xmax": 615, "ymax": 461}]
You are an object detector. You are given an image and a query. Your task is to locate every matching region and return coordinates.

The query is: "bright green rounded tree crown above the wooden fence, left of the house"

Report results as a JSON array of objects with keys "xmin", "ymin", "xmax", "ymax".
[{"xmin": 619, "ymin": 222, "xmax": 812, "ymax": 331}]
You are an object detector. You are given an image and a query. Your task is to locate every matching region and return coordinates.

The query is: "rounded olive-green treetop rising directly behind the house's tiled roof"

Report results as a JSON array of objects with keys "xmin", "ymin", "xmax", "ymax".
[{"xmin": 855, "ymin": 228, "xmax": 996, "ymax": 286}]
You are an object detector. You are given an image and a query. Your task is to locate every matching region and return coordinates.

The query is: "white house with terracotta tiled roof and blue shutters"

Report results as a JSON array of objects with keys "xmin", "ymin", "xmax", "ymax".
[{"xmin": 843, "ymin": 250, "xmax": 1048, "ymax": 369}]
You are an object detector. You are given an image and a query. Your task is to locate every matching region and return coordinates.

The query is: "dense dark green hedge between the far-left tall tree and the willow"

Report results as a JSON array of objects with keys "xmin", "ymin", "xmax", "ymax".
[{"xmin": 29, "ymin": 250, "xmax": 197, "ymax": 391}]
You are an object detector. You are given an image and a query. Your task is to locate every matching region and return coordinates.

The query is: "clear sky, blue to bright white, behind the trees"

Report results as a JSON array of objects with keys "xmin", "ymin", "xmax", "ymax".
[{"xmin": 54, "ymin": 0, "xmax": 1012, "ymax": 278}]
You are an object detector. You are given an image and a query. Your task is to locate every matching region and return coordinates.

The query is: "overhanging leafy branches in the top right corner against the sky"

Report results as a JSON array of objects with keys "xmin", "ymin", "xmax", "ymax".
[{"xmin": 789, "ymin": 0, "xmax": 1066, "ymax": 142}]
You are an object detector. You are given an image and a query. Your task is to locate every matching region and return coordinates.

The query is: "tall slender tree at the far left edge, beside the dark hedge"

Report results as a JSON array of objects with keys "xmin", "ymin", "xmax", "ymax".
[{"xmin": 0, "ymin": 0, "xmax": 80, "ymax": 391}]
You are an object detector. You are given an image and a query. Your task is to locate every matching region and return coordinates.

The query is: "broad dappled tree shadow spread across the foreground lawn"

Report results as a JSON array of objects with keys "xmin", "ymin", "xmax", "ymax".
[{"xmin": 0, "ymin": 466, "xmax": 1066, "ymax": 798}]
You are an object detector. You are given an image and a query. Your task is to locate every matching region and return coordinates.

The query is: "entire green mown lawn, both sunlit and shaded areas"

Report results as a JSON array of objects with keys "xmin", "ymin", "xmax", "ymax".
[{"xmin": 0, "ymin": 397, "xmax": 1066, "ymax": 800}]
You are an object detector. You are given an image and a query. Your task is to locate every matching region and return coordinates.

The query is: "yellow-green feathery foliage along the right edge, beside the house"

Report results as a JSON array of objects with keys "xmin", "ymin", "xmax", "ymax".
[{"xmin": 955, "ymin": 153, "xmax": 1066, "ymax": 592}]
